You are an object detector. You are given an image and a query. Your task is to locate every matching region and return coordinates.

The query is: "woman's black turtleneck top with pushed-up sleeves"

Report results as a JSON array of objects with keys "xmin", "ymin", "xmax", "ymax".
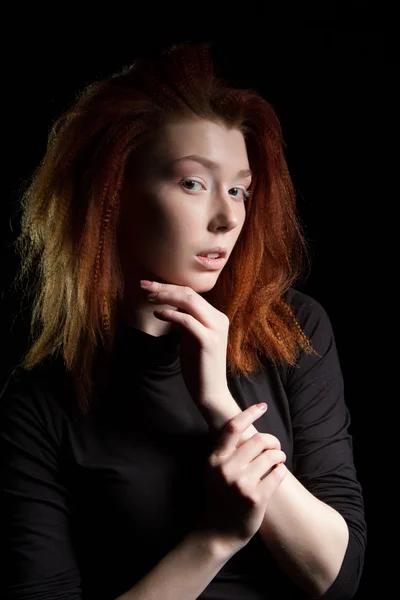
[{"xmin": 0, "ymin": 288, "xmax": 366, "ymax": 600}]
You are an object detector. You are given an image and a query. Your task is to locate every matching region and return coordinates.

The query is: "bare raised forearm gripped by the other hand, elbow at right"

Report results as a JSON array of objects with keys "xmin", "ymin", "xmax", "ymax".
[{"xmin": 206, "ymin": 397, "xmax": 349, "ymax": 597}]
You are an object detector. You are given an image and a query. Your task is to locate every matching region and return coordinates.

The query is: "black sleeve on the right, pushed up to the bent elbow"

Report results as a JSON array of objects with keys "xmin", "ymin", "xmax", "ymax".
[{"xmin": 286, "ymin": 291, "xmax": 367, "ymax": 600}]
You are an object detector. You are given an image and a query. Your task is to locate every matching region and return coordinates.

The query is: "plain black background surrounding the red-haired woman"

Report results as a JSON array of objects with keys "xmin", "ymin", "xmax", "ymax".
[{"xmin": 0, "ymin": 2, "xmax": 398, "ymax": 598}]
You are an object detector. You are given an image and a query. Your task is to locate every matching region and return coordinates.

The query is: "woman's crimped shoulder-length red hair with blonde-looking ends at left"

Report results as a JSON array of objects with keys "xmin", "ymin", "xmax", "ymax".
[{"xmin": 12, "ymin": 44, "xmax": 315, "ymax": 414}]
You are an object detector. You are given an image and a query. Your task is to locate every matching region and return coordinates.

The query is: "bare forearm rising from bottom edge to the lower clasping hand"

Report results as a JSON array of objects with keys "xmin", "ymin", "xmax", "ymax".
[{"xmin": 116, "ymin": 531, "xmax": 232, "ymax": 600}]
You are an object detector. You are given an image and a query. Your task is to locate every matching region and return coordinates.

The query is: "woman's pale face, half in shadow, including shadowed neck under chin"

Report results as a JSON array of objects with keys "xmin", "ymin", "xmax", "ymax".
[{"xmin": 118, "ymin": 120, "xmax": 251, "ymax": 335}]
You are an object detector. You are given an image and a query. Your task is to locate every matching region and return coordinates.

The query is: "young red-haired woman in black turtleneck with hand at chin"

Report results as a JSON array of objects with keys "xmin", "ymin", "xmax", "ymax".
[{"xmin": 0, "ymin": 44, "xmax": 366, "ymax": 600}]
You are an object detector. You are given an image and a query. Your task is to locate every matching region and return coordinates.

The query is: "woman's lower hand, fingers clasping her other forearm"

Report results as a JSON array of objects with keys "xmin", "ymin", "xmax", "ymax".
[{"xmin": 195, "ymin": 404, "xmax": 287, "ymax": 552}]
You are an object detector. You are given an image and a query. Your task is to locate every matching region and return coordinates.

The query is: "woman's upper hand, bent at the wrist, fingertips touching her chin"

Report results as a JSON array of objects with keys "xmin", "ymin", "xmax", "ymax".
[{"xmin": 141, "ymin": 281, "xmax": 231, "ymax": 409}]
